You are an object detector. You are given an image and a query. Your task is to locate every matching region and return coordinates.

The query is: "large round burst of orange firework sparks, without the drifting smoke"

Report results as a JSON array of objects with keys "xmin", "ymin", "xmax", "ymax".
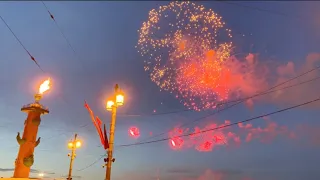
[{"xmin": 137, "ymin": 1, "xmax": 232, "ymax": 110}]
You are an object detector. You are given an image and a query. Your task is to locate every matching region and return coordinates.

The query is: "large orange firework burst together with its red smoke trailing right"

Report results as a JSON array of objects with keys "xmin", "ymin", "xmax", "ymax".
[{"xmin": 137, "ymin": 1, "xmax": 319, "ymax": 111}]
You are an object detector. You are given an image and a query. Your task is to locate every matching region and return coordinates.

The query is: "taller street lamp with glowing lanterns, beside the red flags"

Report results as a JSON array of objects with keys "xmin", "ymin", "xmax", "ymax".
[{"xmin": 105, "ymin": 84, "xmax": 124, "ymax": 180}]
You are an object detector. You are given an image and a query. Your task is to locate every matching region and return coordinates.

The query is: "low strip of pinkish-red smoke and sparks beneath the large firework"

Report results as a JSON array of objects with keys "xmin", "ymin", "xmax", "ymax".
[{"xmin": 169, "ymin": 118, "xmax": 295, "ymax": 152}]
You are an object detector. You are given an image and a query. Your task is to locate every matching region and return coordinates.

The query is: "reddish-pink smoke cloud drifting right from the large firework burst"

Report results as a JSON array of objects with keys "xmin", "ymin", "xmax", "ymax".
[{"xmin": 221, "ymin": 53, "xmax": 320, "ymax": 108}]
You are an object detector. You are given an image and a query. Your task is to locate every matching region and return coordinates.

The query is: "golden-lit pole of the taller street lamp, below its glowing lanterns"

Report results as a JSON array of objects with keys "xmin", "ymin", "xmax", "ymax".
[{"xmin": 106, "ymin": 105, "xmax": 117, "ymax": 180}]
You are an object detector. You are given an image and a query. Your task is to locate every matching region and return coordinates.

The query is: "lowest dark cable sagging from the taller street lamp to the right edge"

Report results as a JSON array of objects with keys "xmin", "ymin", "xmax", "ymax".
[{"xmin": 117, "ymin": 98, "xmax": 320, "ymax": 147}]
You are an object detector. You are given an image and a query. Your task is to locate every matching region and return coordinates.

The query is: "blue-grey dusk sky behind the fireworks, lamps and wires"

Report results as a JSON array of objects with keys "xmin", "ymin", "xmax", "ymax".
[{"xmin": 0, "ymin": 1, "xmax": 320, "ymax": 180}]
